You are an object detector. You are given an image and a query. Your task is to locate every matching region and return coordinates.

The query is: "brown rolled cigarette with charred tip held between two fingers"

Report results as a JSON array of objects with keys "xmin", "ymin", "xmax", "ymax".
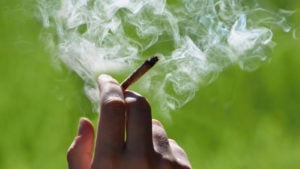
[{"xmin": 121, "ymin": 56, "xmax": 158, "ymax": 91}]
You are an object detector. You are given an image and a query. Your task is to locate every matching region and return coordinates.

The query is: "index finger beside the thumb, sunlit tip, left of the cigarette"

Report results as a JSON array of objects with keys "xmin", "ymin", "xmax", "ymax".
[{"xmin": 95, "ymin": 75, "xmax": 125, "ymax": 159}]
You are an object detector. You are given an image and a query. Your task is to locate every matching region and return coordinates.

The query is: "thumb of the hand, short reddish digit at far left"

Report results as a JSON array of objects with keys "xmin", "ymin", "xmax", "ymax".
[{"xmin": 67, "ymin": 118, "xmax": 95, "ymax": 169}]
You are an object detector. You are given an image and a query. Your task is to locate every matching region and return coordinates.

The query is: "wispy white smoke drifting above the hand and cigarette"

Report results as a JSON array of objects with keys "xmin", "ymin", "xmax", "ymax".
[{"xmin": 38, "ymin": 0, "xmax": 290, "ymax": 115}]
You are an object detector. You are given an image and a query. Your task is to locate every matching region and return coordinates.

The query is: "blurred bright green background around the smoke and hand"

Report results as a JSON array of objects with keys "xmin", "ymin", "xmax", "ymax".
[{"xmin": 0, "ymin": 0, "xmax": 300, "ymax": 169}]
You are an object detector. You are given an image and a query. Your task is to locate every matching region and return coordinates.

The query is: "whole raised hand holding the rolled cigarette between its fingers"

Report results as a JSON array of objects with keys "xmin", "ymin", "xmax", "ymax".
[{"xmin": 67, "ymin": 75, "xmax": 191, "ymax": 169}]
